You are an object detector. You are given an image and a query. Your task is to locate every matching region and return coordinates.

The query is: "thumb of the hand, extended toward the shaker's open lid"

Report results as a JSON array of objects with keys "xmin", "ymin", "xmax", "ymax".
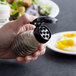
[{"xmin": 12, "ymin": 14, "xmax": 36, "ymax": 28}]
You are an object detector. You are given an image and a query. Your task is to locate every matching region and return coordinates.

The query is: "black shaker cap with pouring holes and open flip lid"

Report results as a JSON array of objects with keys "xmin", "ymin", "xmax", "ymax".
[{"xmin": 31, "ymin": 16, "xmax": 57, "ymax": 43}]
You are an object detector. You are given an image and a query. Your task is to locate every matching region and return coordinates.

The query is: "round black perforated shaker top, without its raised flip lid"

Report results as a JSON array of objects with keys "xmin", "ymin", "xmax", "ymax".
[{"xmin": 33, "ymin": 22, "xmax": 51, "ymax": 43}]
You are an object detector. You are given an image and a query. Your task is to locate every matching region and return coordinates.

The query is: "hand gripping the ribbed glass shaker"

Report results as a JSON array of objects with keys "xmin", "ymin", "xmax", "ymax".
[{"xmin": 0, "ymin": 14, "xmax": 46, "ymax": 63}]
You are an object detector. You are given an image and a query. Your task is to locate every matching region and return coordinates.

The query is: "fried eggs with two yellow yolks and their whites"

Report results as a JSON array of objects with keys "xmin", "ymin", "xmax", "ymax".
[{"xmin": 56, "ymin": 33, "xmax": 76, "ymax": 52}]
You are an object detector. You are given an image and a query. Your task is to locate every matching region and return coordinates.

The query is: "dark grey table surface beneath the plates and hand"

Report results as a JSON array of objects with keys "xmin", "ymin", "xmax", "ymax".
[{"xmin": 0, "ymin": 0, "xmax": 76, "ymax": 76}]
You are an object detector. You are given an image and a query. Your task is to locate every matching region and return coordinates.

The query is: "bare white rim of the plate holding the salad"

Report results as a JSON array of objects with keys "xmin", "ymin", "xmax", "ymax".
[{"xmin": 39, "ymin": 0, "xmax": 60, "ymax": 17}]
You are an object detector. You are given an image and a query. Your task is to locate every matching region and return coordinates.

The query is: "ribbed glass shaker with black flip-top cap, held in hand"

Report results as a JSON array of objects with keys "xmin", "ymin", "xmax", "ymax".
[{"xmin": 11, "ymin": 16, "xmax": 57, "ymax": 57}]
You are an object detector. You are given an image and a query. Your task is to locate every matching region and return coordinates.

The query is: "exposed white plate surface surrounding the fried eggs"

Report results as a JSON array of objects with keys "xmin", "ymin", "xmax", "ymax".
[{"xmin": 47, "ymin": 31, "xmax": 76, "ymax": 55}]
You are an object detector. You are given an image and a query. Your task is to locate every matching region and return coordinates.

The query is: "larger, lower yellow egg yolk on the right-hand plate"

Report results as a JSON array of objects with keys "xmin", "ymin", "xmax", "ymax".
[{"xmin": 57, "ymin": 39, "xmax": 74, "ymax": 50}]
